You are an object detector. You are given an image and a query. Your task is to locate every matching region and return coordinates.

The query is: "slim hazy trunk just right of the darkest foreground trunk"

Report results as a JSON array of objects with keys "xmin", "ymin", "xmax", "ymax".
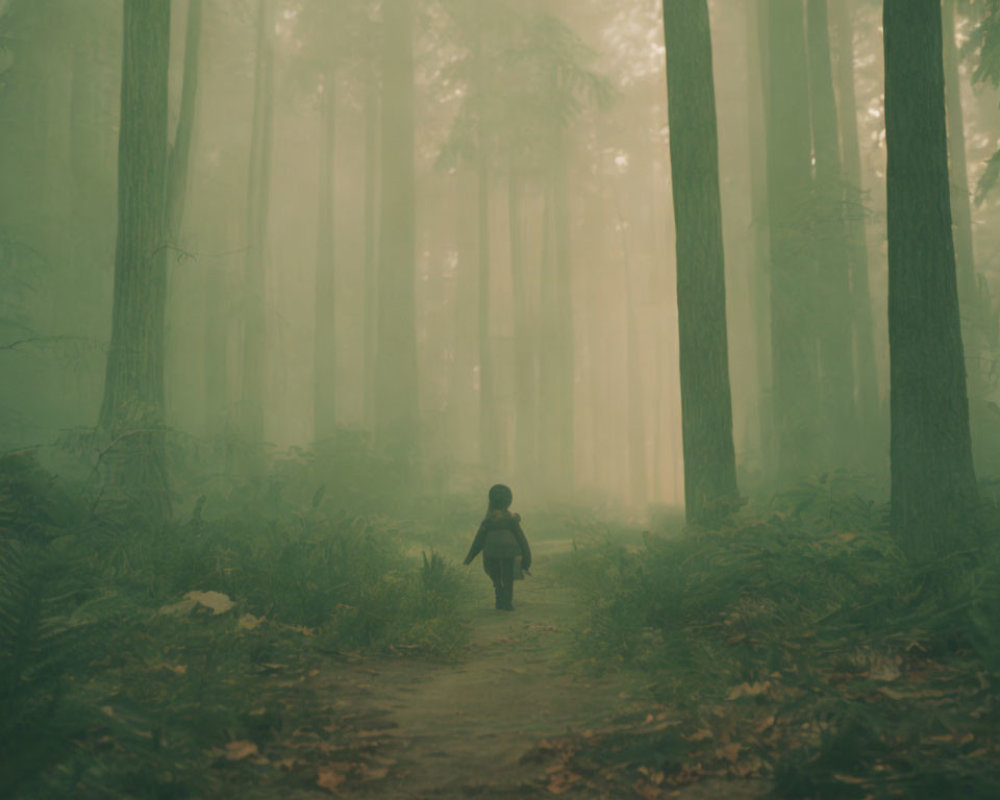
[{"xmin": 941, "ymin": 0, "xmax": 986, "ymax": 406}]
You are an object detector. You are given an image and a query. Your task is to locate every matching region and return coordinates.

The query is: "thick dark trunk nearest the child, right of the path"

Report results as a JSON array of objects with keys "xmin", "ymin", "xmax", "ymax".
[{"xmin": 663, "ymin": 0, "xmax": 739, "ymax": 524}]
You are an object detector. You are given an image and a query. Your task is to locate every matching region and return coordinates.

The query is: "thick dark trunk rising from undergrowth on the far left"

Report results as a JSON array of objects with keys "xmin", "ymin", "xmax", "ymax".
[{"xmin": 100, "ymin": 0, "xmax": 170, "ymax": 519}]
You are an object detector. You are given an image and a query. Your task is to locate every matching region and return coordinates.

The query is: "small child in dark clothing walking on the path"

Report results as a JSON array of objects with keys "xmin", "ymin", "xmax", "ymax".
[{"xmin": 465, "ymin": 483, "xmax": 531, "ymax": 611}]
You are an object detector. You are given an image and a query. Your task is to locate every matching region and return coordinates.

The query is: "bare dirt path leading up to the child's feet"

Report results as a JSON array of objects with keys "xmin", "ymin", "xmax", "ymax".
[{"xmin": 314, "ymin": 565, "xmax": 759, "ymax": 800}]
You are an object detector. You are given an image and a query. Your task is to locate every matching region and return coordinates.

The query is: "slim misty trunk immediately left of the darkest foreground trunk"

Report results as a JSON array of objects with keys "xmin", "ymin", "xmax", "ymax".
[{"xmin": 833, "ymin": 0, "xmax": 885, "ymax": 463}]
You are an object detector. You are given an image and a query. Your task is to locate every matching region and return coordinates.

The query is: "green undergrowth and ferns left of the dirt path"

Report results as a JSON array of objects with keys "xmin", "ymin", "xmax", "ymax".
[{"xmin": 0, "ymin": 456, "xmax": 467, "ymax": 798}]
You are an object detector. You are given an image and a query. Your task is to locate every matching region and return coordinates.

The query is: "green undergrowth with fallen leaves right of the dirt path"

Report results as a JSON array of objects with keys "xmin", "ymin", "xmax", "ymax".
[{"xmin": 560, "ymin": 478, "xmax": 1000, "ymax": 798}]
